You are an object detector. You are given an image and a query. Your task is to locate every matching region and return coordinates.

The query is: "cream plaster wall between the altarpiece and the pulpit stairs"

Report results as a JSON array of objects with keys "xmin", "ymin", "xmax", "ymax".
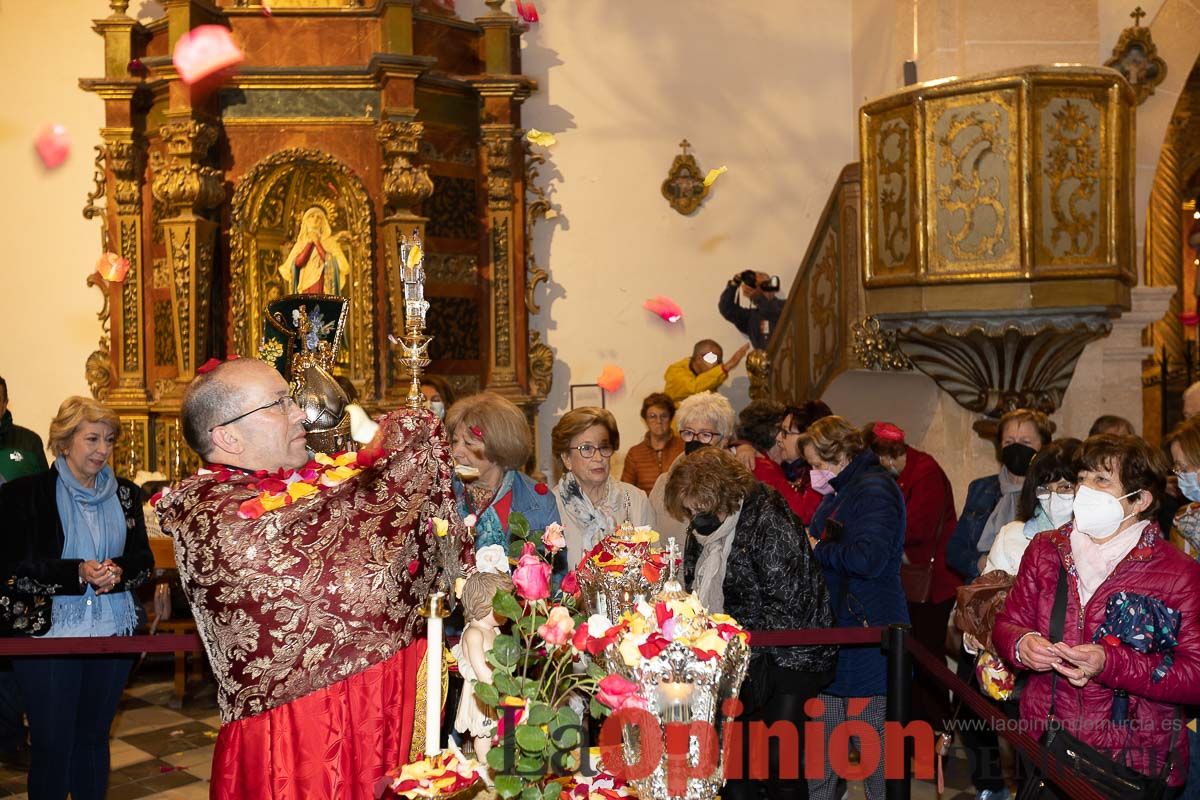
[{"xmin": 492, "ymin": 0, "xmax": 858, "ymax": 471}]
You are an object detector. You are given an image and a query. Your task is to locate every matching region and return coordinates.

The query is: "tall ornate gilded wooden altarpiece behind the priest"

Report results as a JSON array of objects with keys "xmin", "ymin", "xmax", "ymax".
[{"xmin": 79, "ymin": 0, "xmax": 553, "ymax": 479}]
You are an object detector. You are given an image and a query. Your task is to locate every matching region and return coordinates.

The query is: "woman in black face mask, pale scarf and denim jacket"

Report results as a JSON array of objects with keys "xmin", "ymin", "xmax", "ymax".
[{"xmin": 946, "ymin": 408, "xmax": 1054, "ymax": 583}]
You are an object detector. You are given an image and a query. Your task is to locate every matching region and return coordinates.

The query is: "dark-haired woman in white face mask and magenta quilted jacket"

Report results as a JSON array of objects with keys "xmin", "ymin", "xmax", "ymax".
[{"xmin": 992, "ymin": 434, "xmax": 1200, "ymax": 796}]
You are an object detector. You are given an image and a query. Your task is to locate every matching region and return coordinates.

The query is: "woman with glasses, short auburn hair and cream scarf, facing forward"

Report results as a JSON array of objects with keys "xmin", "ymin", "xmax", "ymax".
[{"xmin": 550, "ymin": 407, "xmax": 654, "ymax": 566}]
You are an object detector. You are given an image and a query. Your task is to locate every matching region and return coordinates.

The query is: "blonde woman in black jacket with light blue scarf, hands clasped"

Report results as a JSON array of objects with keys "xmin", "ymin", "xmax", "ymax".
[{"xmin": 0, "ymin": 397, "xmax": 154, "ymax": 800}]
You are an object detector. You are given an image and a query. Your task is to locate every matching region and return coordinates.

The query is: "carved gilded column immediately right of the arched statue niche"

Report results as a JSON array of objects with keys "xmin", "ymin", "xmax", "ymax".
[{"xmin": 379, "ymin": 120, "xmax": 433, "ymax": 403}]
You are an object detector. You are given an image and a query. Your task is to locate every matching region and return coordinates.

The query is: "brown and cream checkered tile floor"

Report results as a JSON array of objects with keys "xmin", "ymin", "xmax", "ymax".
[{"xmin": 0, "ymin": 656, "xmax": 1003, "ymax": 800}]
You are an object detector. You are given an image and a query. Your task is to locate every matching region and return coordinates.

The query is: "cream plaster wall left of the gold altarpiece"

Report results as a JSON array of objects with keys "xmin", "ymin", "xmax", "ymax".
[{"xmin": 0, "ymin": 0, "xmax": 110, "ymax": 439}]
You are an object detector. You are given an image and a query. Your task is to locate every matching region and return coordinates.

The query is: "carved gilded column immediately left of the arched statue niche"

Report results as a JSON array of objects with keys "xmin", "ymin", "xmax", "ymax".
[{"xmin": 154, "ymin": 115, "xmax": 224, "ymax": 395}]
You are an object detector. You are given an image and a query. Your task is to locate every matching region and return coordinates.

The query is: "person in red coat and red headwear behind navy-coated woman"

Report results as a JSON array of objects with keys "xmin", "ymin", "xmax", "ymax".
[{"xmin": 863, "ymin": 422, "xmax": 962, "ymax": 730}]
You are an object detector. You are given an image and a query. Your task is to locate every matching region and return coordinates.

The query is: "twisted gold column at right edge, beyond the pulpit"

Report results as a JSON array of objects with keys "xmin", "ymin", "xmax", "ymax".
[{"xmin": 1146, "ymin": 120, "xmax": 1183, "ymax": 365}]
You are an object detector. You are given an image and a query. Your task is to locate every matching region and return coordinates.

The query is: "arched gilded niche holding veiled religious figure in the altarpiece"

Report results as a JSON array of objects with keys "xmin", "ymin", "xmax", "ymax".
[{"xmin": 230, "ymin": 149, "xmax": 374, "ymax": 397}]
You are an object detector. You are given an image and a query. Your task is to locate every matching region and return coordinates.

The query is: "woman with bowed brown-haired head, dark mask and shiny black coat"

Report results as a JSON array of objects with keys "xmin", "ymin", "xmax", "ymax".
[{"xmin": 666, "ymin": 447, "xmax": 838, "ymax": 799}]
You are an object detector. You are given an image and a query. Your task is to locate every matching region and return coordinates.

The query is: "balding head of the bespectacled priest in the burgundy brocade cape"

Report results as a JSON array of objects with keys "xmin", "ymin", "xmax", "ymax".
[{"xmin": 180, "ymin": 359, "xmax": 308, "ymax": 471}]
